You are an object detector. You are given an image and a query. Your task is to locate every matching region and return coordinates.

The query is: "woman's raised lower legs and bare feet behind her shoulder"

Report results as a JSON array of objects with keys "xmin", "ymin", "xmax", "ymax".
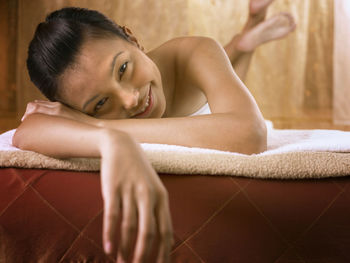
[{"xmin": 224, "ymin": 0, "xmax": 295, "ymax": 81}]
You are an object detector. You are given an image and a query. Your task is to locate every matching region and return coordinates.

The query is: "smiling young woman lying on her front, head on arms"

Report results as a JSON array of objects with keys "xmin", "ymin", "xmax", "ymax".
[{"xmin": 13, "ymin": 0, "xmax": 295, "ymax": 262}]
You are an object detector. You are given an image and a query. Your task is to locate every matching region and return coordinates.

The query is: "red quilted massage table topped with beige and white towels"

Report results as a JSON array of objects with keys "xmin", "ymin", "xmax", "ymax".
[{"xmin": 0, "ymin": 125, "xmax": 350, "ymax": 263}]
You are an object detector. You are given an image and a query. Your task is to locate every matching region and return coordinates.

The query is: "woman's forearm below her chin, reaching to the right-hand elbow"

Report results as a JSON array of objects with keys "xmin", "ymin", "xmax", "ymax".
[{"xmin": 95, "ymin": 113, "xmax": 266, "ymax": 154}]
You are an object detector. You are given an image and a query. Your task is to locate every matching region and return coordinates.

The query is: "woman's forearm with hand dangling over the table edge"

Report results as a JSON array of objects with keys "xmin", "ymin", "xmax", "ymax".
[{"xmin": 13, "ymin": 114, "xmax": 172, "ymax": 262}]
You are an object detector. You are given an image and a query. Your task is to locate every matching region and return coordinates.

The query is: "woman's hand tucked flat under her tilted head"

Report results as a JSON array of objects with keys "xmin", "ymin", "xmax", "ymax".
[{"xmin": 22, "ymin": 100, "xmax": 94, "ymax": 124}]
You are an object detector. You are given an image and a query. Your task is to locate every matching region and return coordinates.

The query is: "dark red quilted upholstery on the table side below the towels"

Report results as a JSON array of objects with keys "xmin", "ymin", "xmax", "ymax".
[{"xmin": 0, "ymin": 168, "xmax": 350, "ymax": 263}]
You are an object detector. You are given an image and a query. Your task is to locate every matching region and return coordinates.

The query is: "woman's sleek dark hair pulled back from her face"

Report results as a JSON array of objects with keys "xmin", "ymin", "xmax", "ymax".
[{"xmin": 27, "ymin": 7, "xmax": 129, "ymax": 101}]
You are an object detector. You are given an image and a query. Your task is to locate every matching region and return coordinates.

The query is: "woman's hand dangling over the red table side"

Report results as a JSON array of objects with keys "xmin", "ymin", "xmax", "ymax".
[{"xmin": 101, "ymin": 131, "xmax": 173, "ymax": 262}]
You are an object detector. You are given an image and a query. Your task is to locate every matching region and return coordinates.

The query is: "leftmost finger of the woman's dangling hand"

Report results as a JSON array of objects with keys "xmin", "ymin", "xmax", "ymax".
[{"xmin": 103, "ymin": 195, "xmax": 120, "ymax": 254}]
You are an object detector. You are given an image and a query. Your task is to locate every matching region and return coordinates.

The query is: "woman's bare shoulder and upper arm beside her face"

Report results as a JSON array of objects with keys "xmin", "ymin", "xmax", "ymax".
[{"xmin": 154, "ymin": 37, "xmax": 258, "ymax": 119}]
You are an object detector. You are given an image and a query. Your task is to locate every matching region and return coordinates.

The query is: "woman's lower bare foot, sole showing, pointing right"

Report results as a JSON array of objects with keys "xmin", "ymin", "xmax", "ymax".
[{"xmin": 236, "ymin": 13, "xmax": 296, "ymax": 52}]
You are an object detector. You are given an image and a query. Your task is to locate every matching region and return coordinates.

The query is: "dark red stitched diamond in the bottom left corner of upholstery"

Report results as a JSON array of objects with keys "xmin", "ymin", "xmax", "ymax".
[{"xmin": 0, "ymin": 187, "xmax": 78, "ymax": 262}]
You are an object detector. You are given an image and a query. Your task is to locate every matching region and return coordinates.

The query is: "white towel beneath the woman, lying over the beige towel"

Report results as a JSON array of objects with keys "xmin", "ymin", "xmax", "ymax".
[{"xmin": 0, "ymin": 121, "xmax": 350, "ymax": 155}]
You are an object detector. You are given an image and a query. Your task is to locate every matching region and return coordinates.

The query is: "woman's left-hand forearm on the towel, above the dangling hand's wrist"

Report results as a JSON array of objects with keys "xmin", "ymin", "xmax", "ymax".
[{"xmin": 12, "ymin": 114, "xmax": 131, "ymax": 158}]
